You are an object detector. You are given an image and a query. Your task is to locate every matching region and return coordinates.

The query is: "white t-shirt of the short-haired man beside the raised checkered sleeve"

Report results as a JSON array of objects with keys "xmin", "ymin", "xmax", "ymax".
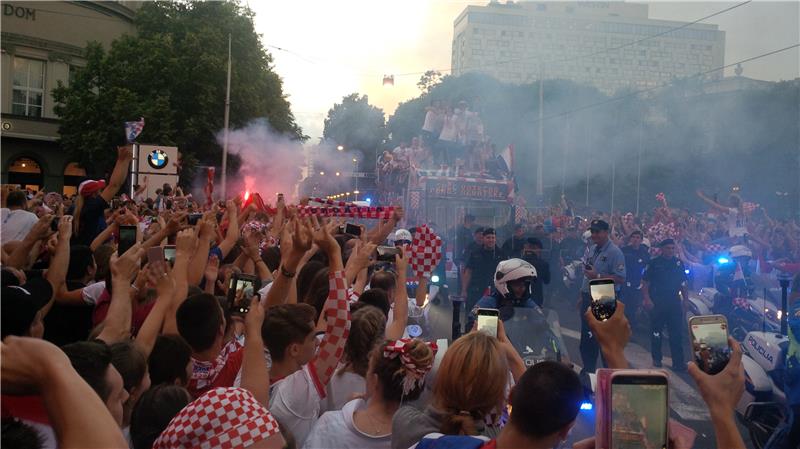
[{"xmin": 269, "ymin": 365, "xmax": 325, "ymax": 447}]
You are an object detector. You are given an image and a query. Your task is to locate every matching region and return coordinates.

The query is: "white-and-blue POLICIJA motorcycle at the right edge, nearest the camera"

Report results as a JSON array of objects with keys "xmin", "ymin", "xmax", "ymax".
[{"xmin": 736, "ymin": 331, "xmax": 789, "ymax": 449}]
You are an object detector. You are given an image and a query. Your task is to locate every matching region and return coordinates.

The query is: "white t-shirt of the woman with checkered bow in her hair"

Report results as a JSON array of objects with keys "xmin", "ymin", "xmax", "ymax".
[{"xmin": 302, "ymin": 399, "xmax": 392, "ymax": 449}]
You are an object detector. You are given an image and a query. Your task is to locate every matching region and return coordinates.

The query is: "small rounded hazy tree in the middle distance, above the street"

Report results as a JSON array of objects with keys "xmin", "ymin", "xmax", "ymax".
[{"xmin": 322, "ymin": 93, "xmax": 386, "ymax": 171}]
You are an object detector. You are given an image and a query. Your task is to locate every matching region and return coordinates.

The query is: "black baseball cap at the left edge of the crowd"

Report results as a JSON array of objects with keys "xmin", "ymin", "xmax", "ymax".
[{"xmin": 0, "ymin": 278, "xmax": 53, "ymax": 338}]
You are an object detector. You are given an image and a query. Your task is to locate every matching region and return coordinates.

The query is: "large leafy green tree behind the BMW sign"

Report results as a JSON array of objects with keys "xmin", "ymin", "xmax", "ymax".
[{"xmin": 53, "ymin": 2, "xmax": 305, "ymax": 182}]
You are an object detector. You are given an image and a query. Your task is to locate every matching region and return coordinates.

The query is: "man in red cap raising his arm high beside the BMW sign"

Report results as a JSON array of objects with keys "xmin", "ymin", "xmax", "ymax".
[{"xmin": 73, "ymin": 145, "xmax": 133, "ymax": 245}]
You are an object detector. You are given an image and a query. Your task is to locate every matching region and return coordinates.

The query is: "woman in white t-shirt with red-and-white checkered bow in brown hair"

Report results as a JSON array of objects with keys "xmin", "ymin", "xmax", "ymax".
[{"xmin": 303, "ymin": 339, "xmax": 436, "ymax": 449}]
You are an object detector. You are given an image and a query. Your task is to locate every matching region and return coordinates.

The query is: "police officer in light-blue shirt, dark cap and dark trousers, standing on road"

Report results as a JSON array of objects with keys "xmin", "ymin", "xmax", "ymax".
[{"xmin": 580, "ymin": 220, "xmax": 625, "ymax": 373}]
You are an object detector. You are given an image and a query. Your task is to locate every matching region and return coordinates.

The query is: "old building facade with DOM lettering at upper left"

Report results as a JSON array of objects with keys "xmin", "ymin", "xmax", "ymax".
[{"xmin": 0, "ymin": 1, "xmax": 141, "ymax": 194}]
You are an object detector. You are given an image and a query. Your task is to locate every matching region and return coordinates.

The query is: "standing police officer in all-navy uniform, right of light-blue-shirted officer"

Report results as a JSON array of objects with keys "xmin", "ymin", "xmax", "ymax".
[{"xmin": 642, "ymin": 239, "xmax": 688, "ymax": 371}]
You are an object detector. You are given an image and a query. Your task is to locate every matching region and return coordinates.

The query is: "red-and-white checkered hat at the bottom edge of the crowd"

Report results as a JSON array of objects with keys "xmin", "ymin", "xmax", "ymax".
[{"xmin": 153, "ymin": 388, "xmax": 279, "ymax": 449}]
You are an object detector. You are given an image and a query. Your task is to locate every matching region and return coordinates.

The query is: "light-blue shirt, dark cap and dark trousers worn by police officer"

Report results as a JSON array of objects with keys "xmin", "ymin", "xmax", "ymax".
[{"xmin": 580, "ymin": 220, "xmax": 625, "ymax": 373}]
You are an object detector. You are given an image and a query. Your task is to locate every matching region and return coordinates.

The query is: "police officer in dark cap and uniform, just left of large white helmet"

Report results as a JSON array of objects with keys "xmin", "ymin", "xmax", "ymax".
[{"xmin": 461, "ymin": 228, "xmax": 506, "ymax": 310}]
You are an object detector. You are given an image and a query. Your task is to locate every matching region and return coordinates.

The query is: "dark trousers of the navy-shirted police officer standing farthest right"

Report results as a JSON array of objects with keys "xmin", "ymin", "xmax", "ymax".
[{"xmin": 650, "ymin": 298, "xmax": 686, "ymax": 368}]
